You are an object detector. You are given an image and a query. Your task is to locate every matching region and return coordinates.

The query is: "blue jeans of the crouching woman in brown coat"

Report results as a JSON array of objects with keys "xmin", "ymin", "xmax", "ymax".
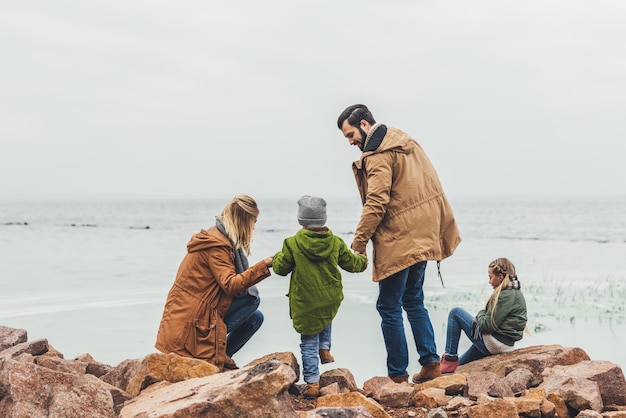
[{"xmin": 224, "ymin": 295, "xmax": 263, "ymax": 357}]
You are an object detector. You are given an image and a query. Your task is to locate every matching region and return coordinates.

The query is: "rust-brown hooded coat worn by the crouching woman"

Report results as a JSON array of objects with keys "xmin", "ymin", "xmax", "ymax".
[{"xmin": 155, "ymin": 227, "xmax": 271, "ymax": 370}]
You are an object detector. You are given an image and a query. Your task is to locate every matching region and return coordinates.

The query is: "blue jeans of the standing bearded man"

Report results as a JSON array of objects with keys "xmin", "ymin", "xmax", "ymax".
[{"xmin": 376, "ymin": 261, "xmax": 439, "ymax": 377}]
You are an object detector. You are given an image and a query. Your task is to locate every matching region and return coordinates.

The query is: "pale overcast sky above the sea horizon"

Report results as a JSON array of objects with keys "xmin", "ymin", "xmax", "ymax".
[{"xmin": 0, "ymin": 0, "xmax": 626, "ymax": 199}]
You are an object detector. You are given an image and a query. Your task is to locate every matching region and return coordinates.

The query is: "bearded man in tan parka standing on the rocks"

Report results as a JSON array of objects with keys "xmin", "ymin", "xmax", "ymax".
[{"xmin": 337, "ymin": 104, "xmax": 461, "ymax": 383}]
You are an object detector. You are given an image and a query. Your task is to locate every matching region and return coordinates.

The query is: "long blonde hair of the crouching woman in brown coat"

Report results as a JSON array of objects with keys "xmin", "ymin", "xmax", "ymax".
[{"xmin": 220, "ymin": 194, "xmax": 259, "ymax": 255}]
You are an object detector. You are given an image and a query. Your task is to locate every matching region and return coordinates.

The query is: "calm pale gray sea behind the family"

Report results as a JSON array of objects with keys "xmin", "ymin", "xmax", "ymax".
[{"xmin": 0, "ymin": 195, "xmax": 626, "ymax": 384}]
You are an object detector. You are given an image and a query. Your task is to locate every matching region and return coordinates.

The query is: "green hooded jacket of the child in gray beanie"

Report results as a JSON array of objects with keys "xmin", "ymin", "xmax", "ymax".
[{"xmin": 272, "ymin": 228, "xmax": 367, "ymax": 335}]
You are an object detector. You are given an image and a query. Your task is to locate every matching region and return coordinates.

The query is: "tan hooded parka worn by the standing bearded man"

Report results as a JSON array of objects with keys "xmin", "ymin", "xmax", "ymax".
[{"xmin": 351, "ymin": 127, "xmax": 461, "ymax": 282}]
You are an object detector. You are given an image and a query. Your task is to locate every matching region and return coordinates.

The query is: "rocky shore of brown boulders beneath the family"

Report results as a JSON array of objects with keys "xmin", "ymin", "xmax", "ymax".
[{"xmin": 0, "ymin": 326, "xmax": 626, "ymax": 418}]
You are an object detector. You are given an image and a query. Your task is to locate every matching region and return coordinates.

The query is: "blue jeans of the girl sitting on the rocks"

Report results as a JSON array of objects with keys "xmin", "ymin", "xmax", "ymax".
[{"xmin": 446, "ymin": 308, "xmax": 490, "ymax": 364}]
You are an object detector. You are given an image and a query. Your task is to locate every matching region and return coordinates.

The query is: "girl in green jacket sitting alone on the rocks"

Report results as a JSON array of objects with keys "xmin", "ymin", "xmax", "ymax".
[{"xmin": 441, "ymin": 258, "xmax": 527, "ymax": 373}]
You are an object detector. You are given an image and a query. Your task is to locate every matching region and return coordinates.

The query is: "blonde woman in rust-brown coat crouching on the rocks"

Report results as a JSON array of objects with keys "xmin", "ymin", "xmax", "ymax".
[{"xmin": 155, "ymin": 195, "xmax": 273, "ymax": 371}]
